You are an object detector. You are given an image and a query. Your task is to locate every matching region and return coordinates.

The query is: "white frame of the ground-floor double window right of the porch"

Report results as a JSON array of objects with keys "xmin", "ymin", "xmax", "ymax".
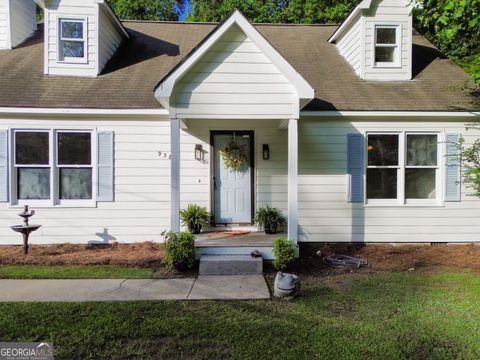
[{"xmin": 363, "ymin": 130, "xmax": 445, "ymax": 207}]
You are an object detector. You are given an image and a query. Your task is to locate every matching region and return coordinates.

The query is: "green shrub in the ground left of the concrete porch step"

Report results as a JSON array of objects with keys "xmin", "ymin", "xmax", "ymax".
[{"xmin": 162, "ymin": 231, "xmax": 195, "ymax": 270}]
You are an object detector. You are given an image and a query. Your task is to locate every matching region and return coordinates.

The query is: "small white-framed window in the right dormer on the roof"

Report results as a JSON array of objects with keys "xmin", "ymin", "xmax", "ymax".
[{"xmin": 374, "ymin": 25, "xmax": 400, "ymax": 67}]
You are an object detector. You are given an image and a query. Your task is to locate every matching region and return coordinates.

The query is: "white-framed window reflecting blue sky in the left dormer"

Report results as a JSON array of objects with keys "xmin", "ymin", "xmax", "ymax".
[{"xmin": 58, "ymin": 19, "xmax": 87, "ymax": 63}]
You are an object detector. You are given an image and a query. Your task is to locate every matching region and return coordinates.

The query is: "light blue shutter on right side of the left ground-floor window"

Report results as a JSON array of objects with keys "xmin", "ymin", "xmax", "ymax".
[{"xmin": 97, "ymin": 131, "xmax": 114, "ymax": 201}]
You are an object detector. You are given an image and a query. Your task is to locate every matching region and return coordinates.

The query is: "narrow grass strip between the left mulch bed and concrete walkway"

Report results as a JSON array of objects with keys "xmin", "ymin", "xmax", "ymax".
[{"xmin": 0, "ymin": 265, "xmax": 155, "ymax": 279}]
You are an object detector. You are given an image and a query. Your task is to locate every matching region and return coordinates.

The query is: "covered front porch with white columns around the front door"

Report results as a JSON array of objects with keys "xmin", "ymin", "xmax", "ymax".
[{"xmin": 170, "ymin": 119, "xmax": 298, "ymax": 258}]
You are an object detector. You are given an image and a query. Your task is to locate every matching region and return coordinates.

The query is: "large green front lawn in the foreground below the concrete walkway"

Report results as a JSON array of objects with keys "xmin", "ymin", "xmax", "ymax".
[{"xmin": 0, "ymin": 270, "xmax": 480, "ymax": 360}]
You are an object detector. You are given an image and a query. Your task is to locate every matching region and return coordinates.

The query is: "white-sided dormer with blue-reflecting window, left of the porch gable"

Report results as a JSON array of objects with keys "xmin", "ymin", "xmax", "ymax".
[{"xmin": 38, "ymin": 0, "xmax": 129, "ymax": 77}]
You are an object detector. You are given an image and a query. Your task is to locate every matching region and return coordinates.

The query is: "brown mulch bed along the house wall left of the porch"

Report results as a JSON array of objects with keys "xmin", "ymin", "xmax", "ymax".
[{"xmin": 0, "ymin": 242, "xmax": 165, "ymax": 267}]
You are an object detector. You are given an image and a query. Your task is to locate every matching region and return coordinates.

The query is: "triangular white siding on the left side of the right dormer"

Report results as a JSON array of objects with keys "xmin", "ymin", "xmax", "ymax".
[{"xmin": 337, "ymin": 16, "xmax": 362, "ymax": 76}]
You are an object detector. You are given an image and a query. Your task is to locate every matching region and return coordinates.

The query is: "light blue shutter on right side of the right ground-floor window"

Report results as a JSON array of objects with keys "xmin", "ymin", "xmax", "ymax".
[{"xmin": 445, "ymin": 134, "xmax": 462, "ymax": 201}]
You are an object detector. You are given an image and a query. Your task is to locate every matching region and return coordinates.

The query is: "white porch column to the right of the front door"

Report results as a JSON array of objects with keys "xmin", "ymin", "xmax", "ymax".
[{"xmin": 287, "ymin": 119, "xmax": 298, "ymax": 243}]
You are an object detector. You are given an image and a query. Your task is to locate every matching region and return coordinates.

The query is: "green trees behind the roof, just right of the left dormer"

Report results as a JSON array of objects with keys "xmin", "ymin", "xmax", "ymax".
[{"xmin": 109, "ymin": 0, "xmax": 180, "ymax": 20}]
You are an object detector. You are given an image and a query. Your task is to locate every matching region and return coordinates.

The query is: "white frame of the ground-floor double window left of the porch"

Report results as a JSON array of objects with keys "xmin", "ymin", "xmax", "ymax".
[{"xmin": 8, "ymin": 127, "xmax": 98, "ymax": 208}]
